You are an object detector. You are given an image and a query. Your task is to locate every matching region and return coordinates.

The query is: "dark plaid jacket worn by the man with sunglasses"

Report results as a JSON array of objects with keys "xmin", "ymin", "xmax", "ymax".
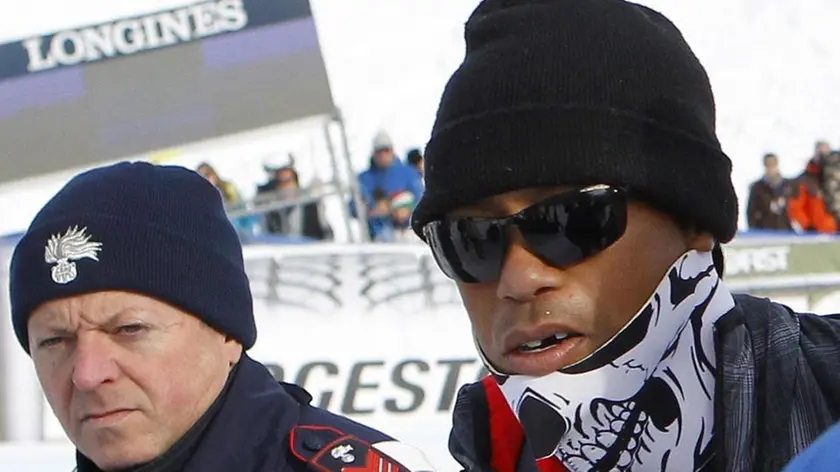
[{"xmin": 449, "ymin": 295, "xmax": 840, "ymax": 472}]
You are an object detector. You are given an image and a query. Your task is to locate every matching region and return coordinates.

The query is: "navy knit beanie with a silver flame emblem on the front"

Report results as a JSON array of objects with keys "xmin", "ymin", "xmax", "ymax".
[{"xmin": 10, "ymin": 162, "xmax": 257, "ymax": 352}]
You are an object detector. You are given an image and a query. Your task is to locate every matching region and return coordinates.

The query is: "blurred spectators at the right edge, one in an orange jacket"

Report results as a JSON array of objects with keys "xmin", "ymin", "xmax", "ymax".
[{"xmin": 746, "ymin": 141, "xmax": 840, "ymax": 233}]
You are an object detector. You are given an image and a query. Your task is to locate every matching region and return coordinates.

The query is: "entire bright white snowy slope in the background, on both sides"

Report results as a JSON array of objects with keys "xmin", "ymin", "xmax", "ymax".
[{"xmin": 0, "ymin": 0, "xmax": 840, "ymax": 234}]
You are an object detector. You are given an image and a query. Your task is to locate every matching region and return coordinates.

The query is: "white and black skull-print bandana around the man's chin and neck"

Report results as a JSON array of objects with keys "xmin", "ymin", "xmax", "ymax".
[{"xmin": 479, "ymin": 251, "xmax": 734, "ymax": 472}]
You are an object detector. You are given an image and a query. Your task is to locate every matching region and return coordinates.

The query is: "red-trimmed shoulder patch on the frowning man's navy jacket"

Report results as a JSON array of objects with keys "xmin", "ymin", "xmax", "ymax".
[{"xmin": 289, "ymin": 426, "xmax": 434, "ymax": 472}]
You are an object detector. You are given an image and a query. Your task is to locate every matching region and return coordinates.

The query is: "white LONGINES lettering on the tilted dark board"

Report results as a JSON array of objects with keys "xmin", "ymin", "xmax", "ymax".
[{"xmin": 22, "ymin": 0, "xmax": 248, "ymax": 72}]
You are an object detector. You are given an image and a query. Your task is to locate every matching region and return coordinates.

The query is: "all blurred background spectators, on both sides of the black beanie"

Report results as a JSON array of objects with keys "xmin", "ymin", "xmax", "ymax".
[{"xmin": 197, "ymin": 131, "xmax": 840, "ymax": 242}]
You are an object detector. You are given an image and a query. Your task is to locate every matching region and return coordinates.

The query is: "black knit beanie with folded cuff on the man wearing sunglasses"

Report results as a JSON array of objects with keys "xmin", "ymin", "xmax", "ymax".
[{"xmin": 412, "ymin": 0, "xmax": 738, "ymax": 242}]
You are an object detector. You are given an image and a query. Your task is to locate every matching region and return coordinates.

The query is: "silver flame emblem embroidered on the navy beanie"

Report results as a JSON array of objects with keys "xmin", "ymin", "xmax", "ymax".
[{"xmin": 44, "ymin": 226, "xmax": 102, "ymax": 285}]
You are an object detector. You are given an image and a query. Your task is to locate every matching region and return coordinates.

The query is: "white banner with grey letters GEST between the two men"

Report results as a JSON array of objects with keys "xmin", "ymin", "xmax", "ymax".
[{"xmin": 245, "ymin": 244, "xmax": 486, "ymax": 471}]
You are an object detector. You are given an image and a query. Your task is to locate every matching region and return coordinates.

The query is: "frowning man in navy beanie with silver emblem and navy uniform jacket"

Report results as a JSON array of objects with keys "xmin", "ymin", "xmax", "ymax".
[{"xmin": 10, "ymin": 162, "xmax": 431, "ymax": 472}]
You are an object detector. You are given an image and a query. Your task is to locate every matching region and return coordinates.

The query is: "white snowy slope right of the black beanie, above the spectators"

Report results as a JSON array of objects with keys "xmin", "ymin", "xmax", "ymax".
[{"xmin": 643, "ymin": 0, "xmax": 840, "ymax": 207}]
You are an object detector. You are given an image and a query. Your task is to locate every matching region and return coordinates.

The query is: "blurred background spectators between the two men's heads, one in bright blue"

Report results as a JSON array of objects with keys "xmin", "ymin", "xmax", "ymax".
[{"xmin": 196, "ymin": 131, "xmax": 423, "ymax": 242}]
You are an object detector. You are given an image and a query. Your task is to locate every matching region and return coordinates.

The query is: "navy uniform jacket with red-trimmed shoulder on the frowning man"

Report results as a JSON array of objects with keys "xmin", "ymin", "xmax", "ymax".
[{"xmin": 77, "ymin": 355, "xmax": 424, "ymax": 472}]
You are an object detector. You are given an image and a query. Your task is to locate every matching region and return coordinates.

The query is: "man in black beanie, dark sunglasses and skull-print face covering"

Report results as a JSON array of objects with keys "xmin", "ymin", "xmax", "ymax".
[{"xmin": 412, "ymin": 0, "xmax": 840, "ymax": 472}]
